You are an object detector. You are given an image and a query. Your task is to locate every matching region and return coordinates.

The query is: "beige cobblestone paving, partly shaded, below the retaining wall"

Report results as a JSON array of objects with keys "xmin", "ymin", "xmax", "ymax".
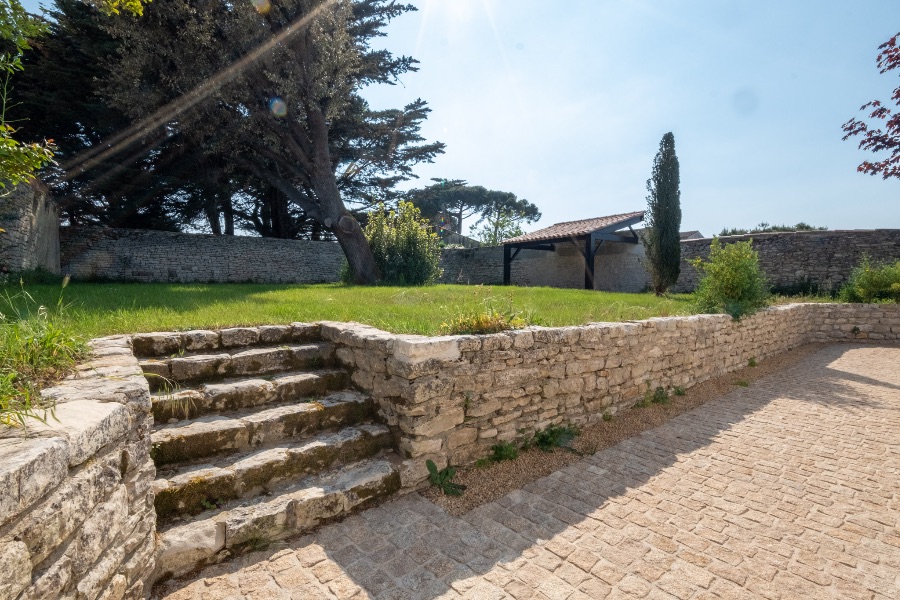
[{"xmin": 160, "ymin": 345, "xmax": 900, "ymax": 600}]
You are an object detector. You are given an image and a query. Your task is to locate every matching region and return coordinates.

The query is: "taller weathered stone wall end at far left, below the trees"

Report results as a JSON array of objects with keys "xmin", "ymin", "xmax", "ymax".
[{"xmin": 0, "ymin": 181, "xmax": 59, "ymax": 273}]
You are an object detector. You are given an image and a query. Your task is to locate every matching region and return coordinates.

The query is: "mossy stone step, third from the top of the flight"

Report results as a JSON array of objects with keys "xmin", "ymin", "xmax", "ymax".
[{"xmin": 148, "ymin": 369, "xmax": 349, "ymax": 424}]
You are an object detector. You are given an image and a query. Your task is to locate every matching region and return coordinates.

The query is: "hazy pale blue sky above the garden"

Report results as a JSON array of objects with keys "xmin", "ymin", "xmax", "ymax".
[{"xmin": 17, "ymin": 0, "xmax": 900, "ymax": 235}]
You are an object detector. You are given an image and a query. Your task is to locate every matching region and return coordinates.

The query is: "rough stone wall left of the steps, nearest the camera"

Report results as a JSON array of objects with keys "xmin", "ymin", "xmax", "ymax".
[{"xmin": 0, "ymin": 336, "xmax": 156, "ymax": 600}]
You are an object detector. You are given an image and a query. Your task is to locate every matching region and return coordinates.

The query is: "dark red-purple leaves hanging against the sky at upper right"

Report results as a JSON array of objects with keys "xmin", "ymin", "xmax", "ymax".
[{"xmin": 842, "ymin": 33, "xmax": 900, "ymax": 179}]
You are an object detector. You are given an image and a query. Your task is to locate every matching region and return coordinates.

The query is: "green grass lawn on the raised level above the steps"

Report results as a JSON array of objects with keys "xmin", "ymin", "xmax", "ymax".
[{"xmin": 0, "ymin": 283, "xmax": 694, "ymax": 337}]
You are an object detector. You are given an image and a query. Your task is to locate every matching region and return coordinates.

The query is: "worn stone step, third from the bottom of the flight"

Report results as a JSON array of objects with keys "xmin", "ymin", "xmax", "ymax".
[{"xmin": 151, "ymin": 391, "xmax": 374, "ymax": 468}]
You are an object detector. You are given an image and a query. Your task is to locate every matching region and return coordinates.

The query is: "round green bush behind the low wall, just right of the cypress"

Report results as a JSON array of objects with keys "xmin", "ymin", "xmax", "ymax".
[{"xmin": 690, "ymin": 238, "xmax": 769, "ymax": 319}]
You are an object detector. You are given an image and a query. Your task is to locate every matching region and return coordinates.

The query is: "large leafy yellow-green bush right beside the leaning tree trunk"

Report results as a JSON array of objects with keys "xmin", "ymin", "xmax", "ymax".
[{"xmin": 365, "ymin": 202, "xmax": 441, "ymax": 285}]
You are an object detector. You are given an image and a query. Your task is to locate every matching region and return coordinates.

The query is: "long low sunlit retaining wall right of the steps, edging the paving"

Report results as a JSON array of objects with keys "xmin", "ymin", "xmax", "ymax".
[{"xmin": 322, "ymin": 304, "xmax": 900, "ymax": 487}]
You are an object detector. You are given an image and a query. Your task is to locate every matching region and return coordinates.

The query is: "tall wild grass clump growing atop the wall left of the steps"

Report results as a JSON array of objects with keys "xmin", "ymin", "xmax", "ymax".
[{"xmin": 0, "ymin": 281, "xmax": 87, "ymax": 427}]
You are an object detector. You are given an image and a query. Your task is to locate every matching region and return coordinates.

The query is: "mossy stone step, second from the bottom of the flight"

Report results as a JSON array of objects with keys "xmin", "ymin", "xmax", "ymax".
[{"xmin": 154, "ymin": 425, "xmax": 393, "ymax": 522}]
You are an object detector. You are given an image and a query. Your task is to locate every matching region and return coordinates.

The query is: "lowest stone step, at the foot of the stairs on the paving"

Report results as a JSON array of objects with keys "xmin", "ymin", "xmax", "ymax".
[{"xmin": 157, "ymin": 452, "xmax": 401, "ymax": 579}]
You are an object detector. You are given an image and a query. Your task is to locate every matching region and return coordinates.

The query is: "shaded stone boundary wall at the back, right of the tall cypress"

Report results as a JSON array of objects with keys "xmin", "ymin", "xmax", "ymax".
[{"xmin": 672, "ymin": 229, "xmax": 900, "ymax": 292}]
